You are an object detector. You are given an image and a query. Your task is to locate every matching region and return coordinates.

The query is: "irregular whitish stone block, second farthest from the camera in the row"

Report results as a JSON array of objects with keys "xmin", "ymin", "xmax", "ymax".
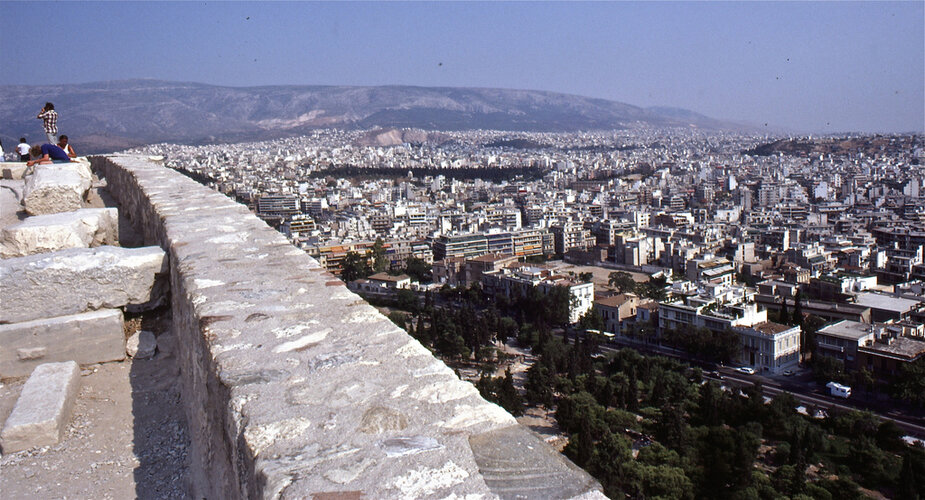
[{"xmin": 0, "ymin": 208, "xmax": 119, "ymax": 259}]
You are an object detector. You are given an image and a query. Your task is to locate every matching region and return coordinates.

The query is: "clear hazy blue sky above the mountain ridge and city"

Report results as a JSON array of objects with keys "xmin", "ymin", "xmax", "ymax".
[{"xmin": 0, "ymin": 1, "xmax": 925, "ymax": 132}]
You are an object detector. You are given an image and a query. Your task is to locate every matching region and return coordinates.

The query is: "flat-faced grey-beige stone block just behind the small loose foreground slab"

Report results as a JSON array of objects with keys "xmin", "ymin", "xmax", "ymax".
[{"xmin": 0, "ymin": 309, "xmax": 125, "ymax": 378}]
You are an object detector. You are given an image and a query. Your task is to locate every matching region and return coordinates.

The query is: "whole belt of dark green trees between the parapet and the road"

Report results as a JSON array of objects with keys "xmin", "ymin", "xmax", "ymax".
[{"xmin": 378, "ymin": 272, "xmax": 925, "ymax": 500}]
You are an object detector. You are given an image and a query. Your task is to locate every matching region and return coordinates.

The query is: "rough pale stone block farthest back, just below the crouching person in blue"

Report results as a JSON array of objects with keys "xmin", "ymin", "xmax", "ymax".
[{"xmin": 22, "ymin": 162, "xmax": 91, "ymax": 215}]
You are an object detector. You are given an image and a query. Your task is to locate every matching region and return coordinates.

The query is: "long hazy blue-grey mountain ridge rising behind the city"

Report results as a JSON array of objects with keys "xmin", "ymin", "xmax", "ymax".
[{"xmin": 0, "ymin": 80, "xmax": 744, "ymax": 154}]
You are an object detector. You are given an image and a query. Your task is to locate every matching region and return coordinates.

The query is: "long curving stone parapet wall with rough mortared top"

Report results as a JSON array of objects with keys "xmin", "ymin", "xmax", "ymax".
[{"xmin": 92, "ymin": 155, "xmax": 603, "ymax": 499}]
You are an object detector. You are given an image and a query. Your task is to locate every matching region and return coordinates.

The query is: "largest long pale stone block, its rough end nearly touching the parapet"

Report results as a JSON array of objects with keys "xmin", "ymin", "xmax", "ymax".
[{"xmin": 0, "ymin": 246, "xmax": 169, "ymax": 323}]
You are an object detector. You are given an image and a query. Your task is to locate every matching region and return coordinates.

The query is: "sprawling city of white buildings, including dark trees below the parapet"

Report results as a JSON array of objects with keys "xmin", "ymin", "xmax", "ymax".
[{"xmin": 130, "ymin": 127, "xmax": 925, "ymax": 498}]
